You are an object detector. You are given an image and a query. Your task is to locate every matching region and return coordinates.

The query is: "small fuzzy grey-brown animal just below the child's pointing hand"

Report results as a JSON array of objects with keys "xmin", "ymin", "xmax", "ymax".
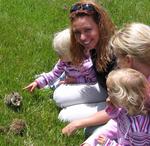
[{"xmin": 4, "ymin": 92, "xmax": 23, "ymax": 108}]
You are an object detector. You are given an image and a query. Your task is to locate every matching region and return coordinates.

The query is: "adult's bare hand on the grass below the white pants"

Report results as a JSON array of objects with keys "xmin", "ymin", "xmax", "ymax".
[{"xmin": 62, "ymin": 120, "xmax": 80, "ymax": 136}]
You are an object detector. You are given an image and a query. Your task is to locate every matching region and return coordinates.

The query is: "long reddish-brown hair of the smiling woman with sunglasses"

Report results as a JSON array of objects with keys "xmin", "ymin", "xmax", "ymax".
[{"xmin": 70, "ymin": 0, "xmax": 115, "ymax": 71}]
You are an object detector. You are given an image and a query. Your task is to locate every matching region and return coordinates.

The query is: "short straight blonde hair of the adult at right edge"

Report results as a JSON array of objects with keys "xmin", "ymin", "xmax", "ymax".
[{"xmin": 110, "ymin": 23, "xmax": 150, "ymax": 65}]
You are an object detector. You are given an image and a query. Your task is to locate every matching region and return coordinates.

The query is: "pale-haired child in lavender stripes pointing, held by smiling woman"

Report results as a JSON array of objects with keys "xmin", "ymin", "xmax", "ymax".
[{"xmin": 25, "ymin": 29, "xmax": 97, "ymax": 92}]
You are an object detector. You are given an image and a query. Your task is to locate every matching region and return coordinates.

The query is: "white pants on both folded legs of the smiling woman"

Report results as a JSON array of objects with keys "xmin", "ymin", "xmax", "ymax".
[{"xmin": 53, "ymin": 83, "xmax": 107, "ymax": 121}]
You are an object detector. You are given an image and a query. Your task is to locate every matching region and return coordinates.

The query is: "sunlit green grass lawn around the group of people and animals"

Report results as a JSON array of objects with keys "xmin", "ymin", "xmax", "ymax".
[{"xmin": 0, "ymin": 0, "xmax": 150, "ymax": 146}]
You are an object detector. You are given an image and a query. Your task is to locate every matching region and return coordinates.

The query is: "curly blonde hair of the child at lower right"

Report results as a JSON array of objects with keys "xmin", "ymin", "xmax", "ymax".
[{"xmin": 107, "ymin": 68, "xmax": 150, "ymax": 115}]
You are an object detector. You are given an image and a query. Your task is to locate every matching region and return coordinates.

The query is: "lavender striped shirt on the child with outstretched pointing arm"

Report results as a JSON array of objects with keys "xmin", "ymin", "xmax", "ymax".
[{"xmin": 36, "ymin": 58, "xmax": 97, "ymax": 88}]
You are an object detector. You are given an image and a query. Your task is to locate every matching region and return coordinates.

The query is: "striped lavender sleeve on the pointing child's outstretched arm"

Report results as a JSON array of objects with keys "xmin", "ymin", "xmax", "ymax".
[{"xmin": 36, "ymin": 60, "xmax": 65, "ymax": 88}]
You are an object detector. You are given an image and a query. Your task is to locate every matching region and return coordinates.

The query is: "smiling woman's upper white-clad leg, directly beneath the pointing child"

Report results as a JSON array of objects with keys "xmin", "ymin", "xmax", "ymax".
[{"xmin": 53, "ymin": 83, "xmax": 107, "ymax": 108}]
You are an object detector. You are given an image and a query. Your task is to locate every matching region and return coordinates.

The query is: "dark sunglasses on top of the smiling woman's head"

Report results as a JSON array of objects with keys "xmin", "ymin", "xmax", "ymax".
[{"xmin": 70, "ymin": 4, "xmax": 95, "ymax": 13}]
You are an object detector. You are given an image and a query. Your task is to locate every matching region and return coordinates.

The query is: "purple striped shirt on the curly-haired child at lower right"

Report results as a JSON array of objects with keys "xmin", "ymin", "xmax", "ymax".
[{"xmin": 104, "ymin": 106, "xmax": 150, "ymax": 146}]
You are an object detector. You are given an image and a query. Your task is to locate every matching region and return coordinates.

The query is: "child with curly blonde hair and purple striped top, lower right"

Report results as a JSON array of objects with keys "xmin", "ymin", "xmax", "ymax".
[{"xmin": 97, "ymin": 68, "xmax": 150, "ymax": 146}]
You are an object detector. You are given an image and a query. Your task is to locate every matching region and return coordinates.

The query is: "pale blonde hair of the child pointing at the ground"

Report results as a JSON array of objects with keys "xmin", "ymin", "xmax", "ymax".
[{"xmin": 53, "ymin": 28, "xmax": 71, "ymax": 58}]
